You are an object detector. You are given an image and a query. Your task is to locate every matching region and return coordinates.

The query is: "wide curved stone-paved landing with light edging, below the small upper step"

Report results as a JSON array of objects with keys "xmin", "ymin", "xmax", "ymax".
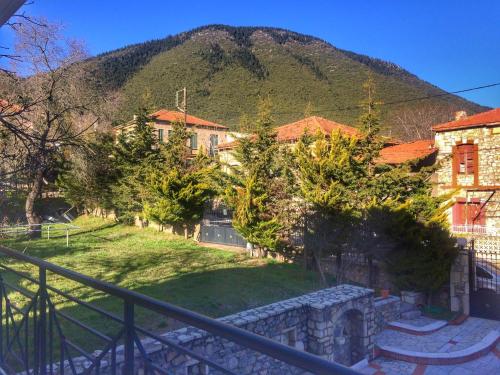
[{"xmin": 375, "ymin": 318, "xmax": 500, "ymax": 353}]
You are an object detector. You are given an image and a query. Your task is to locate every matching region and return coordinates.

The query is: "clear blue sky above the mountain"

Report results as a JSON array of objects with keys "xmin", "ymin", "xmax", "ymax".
[{"xmin": 0, "ymin": 0, "xmax": 500, "ymax": 107}]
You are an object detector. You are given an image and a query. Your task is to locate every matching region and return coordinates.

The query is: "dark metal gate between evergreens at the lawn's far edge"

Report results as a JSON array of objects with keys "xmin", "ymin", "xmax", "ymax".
[{"xmin": 200, "ymin": 201, "xmax": 247, "ymax": 247}]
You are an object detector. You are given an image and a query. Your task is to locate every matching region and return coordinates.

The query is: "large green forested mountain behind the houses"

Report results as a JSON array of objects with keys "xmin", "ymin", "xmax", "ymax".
[{"xmin": 87, "ymin": 25, "xmax": 485, "ymax": 135}]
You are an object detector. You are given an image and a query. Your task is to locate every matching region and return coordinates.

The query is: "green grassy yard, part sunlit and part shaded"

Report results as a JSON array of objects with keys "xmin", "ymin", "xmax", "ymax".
[{"xmin": 0, "ymin": 217, "xmax": 321, "ymax": 346}]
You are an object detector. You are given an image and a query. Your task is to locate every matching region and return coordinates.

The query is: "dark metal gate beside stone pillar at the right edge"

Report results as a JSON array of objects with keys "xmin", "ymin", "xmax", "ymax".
[{"xmin": 469, "ymin": 241, "xmax": 500, "ymax": 320}]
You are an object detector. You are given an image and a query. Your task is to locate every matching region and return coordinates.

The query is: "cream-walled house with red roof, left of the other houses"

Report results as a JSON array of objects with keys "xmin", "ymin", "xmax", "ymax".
[{"xmin": 114, "ymin": 109, "xmax": 232, "ymax": 155}]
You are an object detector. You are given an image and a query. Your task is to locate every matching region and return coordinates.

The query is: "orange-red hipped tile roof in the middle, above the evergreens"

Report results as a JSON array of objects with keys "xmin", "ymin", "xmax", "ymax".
[{"xmin": 218, "ymin": 116, "xmax": 361, "ymax": 150}]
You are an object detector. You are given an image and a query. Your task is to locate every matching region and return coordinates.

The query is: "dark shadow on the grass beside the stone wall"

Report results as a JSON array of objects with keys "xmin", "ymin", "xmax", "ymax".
[{"xmin": 2, "ymin": 263, "xmax": 332, "ymax": 352}]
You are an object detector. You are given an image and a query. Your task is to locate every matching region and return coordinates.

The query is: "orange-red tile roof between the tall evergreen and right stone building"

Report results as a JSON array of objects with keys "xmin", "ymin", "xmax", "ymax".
[{"xmin": 377, "ymin": 139, "xmax": 437, "ymax": 164}]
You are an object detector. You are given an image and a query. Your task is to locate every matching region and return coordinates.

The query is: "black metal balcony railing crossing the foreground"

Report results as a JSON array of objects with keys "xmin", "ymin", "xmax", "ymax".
[{"xmin": 0, "ymin": 246, "xmax": 357, "ymax": 375}]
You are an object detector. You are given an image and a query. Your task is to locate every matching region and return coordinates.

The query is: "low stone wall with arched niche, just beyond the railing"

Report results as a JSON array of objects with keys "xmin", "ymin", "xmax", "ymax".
[{"xmin": 62, "ymin": 285, "xmax": 376, "ymax": 375}]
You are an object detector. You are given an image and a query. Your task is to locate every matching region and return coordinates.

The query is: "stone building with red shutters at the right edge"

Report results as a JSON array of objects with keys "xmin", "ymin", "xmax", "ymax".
[{"xmin": 432, "ymin": 108, "xmax": 500, "ymax": 236}]
